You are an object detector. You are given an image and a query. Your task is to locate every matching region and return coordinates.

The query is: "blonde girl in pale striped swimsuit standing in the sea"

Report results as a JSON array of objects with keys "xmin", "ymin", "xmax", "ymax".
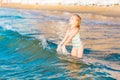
[{"xmin": 57, "ymin": 14, "xmax": 83, "ymax": 58}]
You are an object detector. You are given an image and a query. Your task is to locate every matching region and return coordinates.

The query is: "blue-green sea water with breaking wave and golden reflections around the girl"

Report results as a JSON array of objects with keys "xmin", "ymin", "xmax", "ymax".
[{"xmin": 0, "ymin": 8, "xmax": 120, "ymax": 80}]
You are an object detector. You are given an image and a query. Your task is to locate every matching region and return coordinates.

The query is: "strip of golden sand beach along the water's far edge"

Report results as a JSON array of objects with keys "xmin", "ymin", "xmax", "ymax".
[{"xmin": 0, "ymin": 3, "xmax": 120, "ymax": 17}]
